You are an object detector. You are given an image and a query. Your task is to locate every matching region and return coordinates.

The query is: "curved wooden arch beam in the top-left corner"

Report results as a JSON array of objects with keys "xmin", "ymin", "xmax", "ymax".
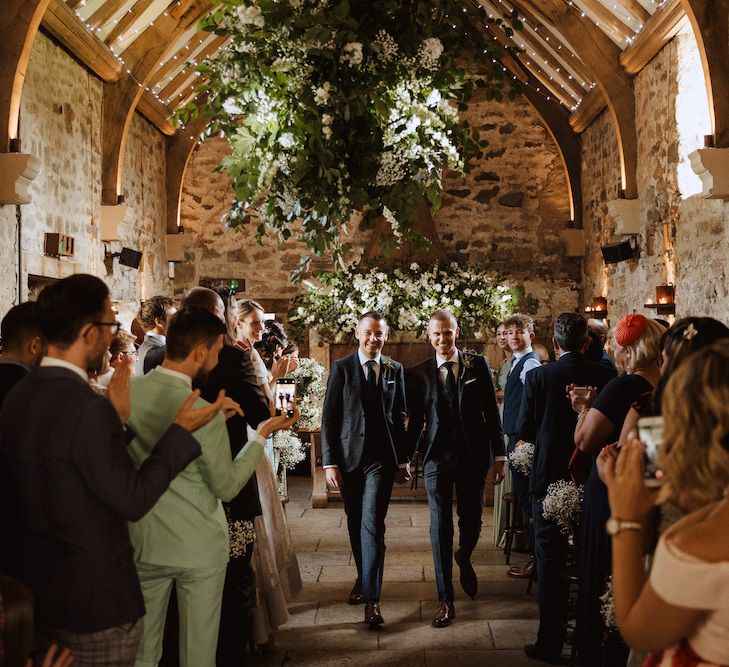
[{"xmin": 0, "ymin": 0, "xmax": 50, "ymax": 153}]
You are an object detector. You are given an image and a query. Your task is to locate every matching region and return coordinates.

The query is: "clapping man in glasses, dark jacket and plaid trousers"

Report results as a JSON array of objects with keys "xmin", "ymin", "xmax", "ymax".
[{"xmin": 0, "ymin": 274, "xmax": 222, "ymax": 667}]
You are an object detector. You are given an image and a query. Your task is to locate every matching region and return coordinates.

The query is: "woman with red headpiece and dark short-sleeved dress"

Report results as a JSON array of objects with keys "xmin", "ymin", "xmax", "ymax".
[{"xmin": 569, "ymin": 314, "xmax": 665, "ymax": 667}]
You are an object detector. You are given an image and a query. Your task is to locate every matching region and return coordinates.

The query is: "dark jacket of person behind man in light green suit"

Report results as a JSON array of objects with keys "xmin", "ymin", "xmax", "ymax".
[{"xmin": 198, "ymin": 345, "xmax": 271, "ymax": 521}]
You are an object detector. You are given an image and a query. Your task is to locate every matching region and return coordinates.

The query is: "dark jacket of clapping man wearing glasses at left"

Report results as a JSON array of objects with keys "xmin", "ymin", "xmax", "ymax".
[{"xmin": 0, "ymin": 367, "xmax": 201, "ymax": 633}]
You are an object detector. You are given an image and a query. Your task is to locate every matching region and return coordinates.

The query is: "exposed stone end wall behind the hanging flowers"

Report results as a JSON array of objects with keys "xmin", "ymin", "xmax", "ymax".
[{"xmin": 175, "ymin": 86, "xmax": 580, "ymax": 339}]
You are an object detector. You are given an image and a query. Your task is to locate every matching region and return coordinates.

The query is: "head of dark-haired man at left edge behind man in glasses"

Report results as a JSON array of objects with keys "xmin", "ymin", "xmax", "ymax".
[{"xmin": 0, "ymin": 301, "xmax": 44, "ymax": 408}]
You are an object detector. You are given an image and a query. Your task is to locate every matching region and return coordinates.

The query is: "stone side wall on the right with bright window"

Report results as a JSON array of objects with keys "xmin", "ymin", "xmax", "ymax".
[{"xmin": 581, "ymin": 32, "xmax": 729, "ymax": 323}]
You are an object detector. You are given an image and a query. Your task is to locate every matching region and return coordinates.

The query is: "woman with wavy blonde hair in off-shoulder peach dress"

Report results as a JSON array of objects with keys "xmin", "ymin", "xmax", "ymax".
[{"xmin": 605, "ymin": 340, "xmax": 729, "ymax": 667}]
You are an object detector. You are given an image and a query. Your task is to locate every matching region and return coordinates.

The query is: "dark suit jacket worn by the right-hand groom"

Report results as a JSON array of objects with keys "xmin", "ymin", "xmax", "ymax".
[{"xmin": 408, "ymin": 350, "xmax": 504, "ymax": 470}]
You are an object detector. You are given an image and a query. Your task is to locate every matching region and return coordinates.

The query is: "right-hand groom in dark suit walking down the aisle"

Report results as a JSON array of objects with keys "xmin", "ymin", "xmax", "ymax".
[{"xmin": 408, "ymin": 310, "xmax": 505, "ymax": 628}]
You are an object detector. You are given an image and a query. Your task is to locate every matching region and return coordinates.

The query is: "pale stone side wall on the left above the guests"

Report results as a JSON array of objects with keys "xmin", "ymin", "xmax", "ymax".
[{"xmin": 0, "ymin": 33, "xmax": 171, "ymax": 325}]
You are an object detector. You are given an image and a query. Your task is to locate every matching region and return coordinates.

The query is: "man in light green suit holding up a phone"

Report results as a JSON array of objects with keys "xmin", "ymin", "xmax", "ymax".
[{"xmin": 129, "ymin": 309, "xmax": 296, "ymax": 667}]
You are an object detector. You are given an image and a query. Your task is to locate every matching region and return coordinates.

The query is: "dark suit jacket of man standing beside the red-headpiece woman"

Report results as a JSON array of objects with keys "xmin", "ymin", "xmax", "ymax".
[{"xmin": 517, "ymin": 352, "xmax": 615, "ymax": 498}]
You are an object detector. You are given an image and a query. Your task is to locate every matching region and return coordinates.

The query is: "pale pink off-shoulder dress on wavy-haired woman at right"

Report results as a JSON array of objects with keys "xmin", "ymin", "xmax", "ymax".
[{"xmin": 644, "ymin": 536, "xmax": 729, "ymax": 667}]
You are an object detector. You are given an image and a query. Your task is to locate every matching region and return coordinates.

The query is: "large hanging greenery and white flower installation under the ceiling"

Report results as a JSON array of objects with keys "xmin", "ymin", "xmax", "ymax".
[{"xmin": 177, "ymin": 0, "xmax": 521, "ymax": 269}]
